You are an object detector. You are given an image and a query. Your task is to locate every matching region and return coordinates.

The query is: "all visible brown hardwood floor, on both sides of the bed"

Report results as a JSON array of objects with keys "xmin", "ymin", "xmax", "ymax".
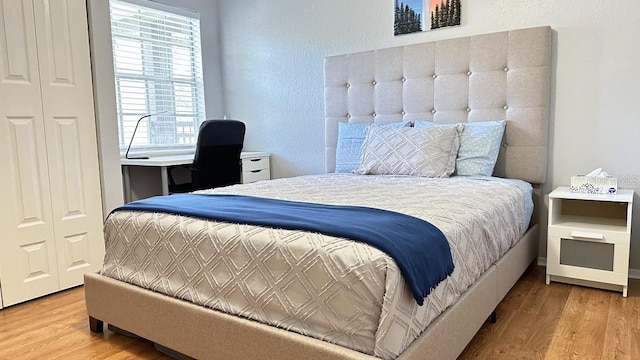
[{"xmin": 0, "ymin": 267, "xmax": 640, "ymax": 360}]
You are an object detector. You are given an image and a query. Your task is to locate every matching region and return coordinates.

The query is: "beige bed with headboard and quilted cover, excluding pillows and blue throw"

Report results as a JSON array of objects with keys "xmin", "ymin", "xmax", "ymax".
[{"xmin": 85, "ymin": 27, "xmax": 551, "ymax": 360}]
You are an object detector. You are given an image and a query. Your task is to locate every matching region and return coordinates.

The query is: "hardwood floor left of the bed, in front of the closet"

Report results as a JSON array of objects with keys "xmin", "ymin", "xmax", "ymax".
[{"xmin": 0, "ymin": 287, "xmax": 171, "ymax": 360}]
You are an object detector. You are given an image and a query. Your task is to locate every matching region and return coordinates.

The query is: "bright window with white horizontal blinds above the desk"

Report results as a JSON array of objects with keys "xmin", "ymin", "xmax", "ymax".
[{"xmin": 109, "ymin": 0, "xmax": 205, "ymax": 152}]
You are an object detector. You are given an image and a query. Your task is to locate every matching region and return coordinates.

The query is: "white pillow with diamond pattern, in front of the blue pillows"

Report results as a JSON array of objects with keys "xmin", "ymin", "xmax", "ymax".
[{"xmin": 356, "ymin": 124, "xmax": 464, "ymax": 177}]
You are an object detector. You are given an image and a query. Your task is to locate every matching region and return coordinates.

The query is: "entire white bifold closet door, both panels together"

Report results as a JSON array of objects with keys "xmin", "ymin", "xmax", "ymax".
[{"xmin": 0, "ymin": 0, "xmax": 104, "ymax": 306}]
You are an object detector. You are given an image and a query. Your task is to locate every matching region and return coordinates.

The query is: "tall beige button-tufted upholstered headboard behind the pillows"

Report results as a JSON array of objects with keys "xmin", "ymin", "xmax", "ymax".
[{"xmin": 325, "ymin": 26, "xmax": 551, "ymax": 184}]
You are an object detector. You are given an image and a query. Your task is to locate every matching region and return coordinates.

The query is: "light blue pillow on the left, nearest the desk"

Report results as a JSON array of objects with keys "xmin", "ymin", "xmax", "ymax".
[{"xmin": 336, "ymin": 121, "xmax": 411, "ymax": 173}]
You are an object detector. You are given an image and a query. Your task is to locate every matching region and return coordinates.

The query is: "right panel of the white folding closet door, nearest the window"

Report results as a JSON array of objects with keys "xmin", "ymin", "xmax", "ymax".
[{"xmin": 33, "ymin": 0, "xmax": 104, "ymax": 289}]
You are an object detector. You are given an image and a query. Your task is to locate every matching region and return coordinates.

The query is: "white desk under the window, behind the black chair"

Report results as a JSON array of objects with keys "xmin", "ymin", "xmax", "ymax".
[{"xmin": 120, "ymin": 151, "xmax": 271, "ymax": 202}]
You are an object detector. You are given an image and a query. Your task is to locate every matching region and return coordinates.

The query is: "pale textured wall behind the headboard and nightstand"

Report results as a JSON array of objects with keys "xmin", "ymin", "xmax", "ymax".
[{"xmin": 219, "ymin": 0, "xmax": 640, "ymax": 269}]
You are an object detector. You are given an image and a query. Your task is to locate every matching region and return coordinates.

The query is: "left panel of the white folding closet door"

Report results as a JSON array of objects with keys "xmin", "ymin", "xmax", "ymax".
[{"xmin": 0, "ymin": 0, "xmax": 59, "ymax": 306}]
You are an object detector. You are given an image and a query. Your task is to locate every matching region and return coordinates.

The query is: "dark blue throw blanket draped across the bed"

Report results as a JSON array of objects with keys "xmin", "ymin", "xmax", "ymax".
[{"xmin": 114, "ymin": 194, "xmax": 453, "ymax": 305}]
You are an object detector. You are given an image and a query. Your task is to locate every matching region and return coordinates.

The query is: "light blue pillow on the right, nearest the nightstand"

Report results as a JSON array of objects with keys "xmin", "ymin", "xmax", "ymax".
[{"xmin": 414, "ymin": 120, "xmax": 507, "ymax": 176}]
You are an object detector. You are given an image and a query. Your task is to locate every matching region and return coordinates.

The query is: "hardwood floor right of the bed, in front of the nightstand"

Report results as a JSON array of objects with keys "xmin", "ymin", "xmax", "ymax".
[{"xmin": 459, "ymin": 267, "xmax": 640, "ymax": 360}]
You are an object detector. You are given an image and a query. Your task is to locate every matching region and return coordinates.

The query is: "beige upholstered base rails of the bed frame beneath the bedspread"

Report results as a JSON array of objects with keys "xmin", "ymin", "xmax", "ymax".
[{"xmin": 85, "ymin": 225, "xmax": 538, "ymax": 360}]
